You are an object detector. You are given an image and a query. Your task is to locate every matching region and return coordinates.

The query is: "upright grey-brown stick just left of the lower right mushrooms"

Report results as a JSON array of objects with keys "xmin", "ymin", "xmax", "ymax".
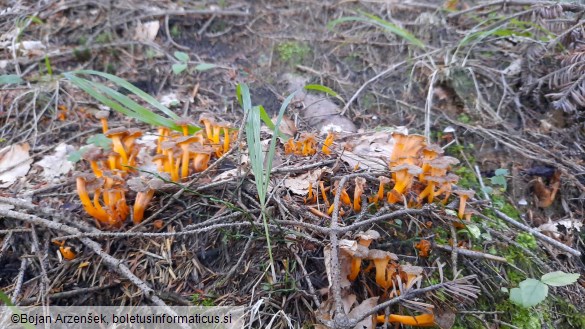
[{"xmin": 329, "ymin": 177, "xmax": 349, "ymax": 327}]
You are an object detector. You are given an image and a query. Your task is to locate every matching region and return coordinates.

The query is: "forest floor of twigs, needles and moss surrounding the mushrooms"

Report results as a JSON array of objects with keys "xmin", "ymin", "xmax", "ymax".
[{"xmin": 0, "ymin": 0, "xmax": 585, "ymax": 328}]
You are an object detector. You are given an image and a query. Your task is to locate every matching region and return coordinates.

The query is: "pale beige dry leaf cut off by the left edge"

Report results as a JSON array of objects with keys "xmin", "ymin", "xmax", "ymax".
[{"xmin": 0, "ymin": 143, "xmax": 33, "ymax": 188}]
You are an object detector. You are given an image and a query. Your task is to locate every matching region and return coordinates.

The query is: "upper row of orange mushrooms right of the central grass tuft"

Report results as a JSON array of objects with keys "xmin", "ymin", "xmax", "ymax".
[{"xmin": 306, "ymin": 132, "xmax": 475, "ymax": 221}]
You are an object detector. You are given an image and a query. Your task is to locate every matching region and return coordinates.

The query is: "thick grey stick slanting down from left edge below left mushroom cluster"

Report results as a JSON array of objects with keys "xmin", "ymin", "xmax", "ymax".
[{"xmin": 0, "ymin": 209, "xmax": 174, "ymax": 314}]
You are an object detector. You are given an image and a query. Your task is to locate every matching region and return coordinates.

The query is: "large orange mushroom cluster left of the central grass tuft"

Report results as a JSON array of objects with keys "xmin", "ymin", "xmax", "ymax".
[{"xmin": 76, "ymin": 111, "xmax": 233, "ymax": 228}]
